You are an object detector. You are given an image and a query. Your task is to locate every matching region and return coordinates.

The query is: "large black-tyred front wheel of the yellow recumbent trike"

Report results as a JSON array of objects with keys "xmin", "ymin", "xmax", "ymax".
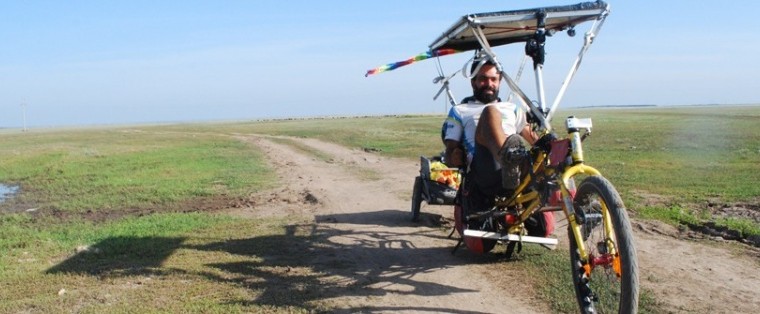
[{"xmin": 568, "ymin": 176, "xmax": 639, "ymax": 313}]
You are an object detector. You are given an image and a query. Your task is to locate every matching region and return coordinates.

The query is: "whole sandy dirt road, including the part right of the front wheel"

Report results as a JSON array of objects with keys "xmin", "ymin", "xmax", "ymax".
[{"xmin": 237, "ymin": 135, "xmax": 760, "ymax": 313}]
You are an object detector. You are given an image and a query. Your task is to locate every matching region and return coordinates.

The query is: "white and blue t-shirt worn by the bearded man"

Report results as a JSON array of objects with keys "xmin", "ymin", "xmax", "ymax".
[{"xmin": 443, "ymin": 101, "xmax": 528, "ymax": 164}]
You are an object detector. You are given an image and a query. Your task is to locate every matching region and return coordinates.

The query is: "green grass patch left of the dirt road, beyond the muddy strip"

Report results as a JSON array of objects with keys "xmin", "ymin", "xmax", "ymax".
[{"xmin": 0, "ymin": 129, "xmax": 274, "ymax": 212}]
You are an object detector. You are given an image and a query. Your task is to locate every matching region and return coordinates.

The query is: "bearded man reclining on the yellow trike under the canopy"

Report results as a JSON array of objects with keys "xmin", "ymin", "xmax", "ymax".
[{"xmin": 443, "ymin": 60, "xmax": 538, "ymax": 201}]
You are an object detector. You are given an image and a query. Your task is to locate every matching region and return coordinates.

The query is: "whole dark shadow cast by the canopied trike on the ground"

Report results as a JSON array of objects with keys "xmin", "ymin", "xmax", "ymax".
[{"xmin": 47, "ymin": 210, "xmax": 496, "ymax": 313}]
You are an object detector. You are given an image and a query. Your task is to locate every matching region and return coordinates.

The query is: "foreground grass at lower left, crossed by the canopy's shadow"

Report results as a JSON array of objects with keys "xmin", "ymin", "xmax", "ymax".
[{"xmin": 0, "ymin": 213, "xmax": 321, "ymax": 313}]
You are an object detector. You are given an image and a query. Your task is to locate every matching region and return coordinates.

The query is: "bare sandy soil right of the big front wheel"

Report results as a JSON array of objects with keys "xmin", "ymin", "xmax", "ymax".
[{"xmin": 633, "ymin": 220, "xmax": 760, "ymax": 313}]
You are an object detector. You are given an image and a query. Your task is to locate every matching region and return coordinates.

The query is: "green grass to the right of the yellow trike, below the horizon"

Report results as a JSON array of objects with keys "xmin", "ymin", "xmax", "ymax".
[{"xmin": 580, "ymin": 106, "xmax": 760, "ymax": 202}]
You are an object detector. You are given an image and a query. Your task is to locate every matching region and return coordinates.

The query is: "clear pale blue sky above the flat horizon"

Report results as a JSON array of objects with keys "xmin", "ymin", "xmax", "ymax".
[{"xmin": 0, "ymin": 0, "xmax": 760, "ymax": 128}]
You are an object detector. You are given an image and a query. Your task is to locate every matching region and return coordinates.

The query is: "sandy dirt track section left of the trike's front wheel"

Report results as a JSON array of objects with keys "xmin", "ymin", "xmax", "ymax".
[{"xmin": 238, "ymin": 136, "xmax": 549, "ymax": 313}]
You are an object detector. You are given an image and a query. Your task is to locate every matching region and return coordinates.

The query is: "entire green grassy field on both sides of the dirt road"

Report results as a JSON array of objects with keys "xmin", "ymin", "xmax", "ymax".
[{"xmin": 0, "ymin": 106, "xmax": 760, "ymax": 313}]
